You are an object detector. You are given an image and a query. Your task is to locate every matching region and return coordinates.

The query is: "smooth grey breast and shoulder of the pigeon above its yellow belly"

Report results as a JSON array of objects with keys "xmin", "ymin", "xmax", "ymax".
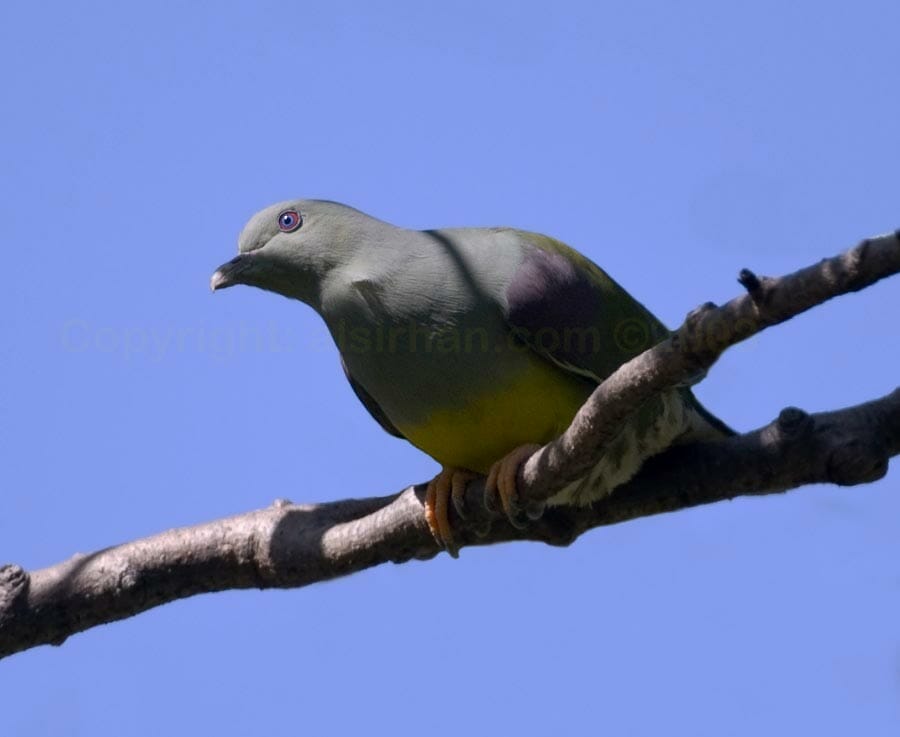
[{"xmin": 323, "ymin": 230, "xmax": 524, "ymax": 425}]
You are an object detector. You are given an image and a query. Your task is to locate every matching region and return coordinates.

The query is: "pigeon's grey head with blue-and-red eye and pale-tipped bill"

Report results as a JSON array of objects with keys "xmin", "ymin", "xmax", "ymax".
[{"xmin": 209, "ymin": 200, "xmax": 391, "ymax": 306}]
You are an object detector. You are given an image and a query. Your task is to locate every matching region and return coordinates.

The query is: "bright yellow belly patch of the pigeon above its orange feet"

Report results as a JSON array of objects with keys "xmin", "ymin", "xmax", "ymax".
[{"xmin": 397, "ymin": 357, "xmax": 591, "ymax": 473}]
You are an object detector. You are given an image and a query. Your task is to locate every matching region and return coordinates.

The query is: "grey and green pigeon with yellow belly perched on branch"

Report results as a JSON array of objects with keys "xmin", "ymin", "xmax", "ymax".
[{"xmin": 210, "ymin": 199, "xmax": 733, "ymax": 557}]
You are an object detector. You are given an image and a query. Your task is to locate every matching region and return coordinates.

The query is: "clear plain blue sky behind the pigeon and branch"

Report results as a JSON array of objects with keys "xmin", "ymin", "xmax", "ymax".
[{"xmin": 0, "ymin": 0, "xmax": 900, "ymax": 737}]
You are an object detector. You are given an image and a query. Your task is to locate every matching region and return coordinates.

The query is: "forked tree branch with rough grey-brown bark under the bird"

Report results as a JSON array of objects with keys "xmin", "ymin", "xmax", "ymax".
[{"xmin": 0, "ymin": 233, "xmax": 900, "ymax": 657}]
